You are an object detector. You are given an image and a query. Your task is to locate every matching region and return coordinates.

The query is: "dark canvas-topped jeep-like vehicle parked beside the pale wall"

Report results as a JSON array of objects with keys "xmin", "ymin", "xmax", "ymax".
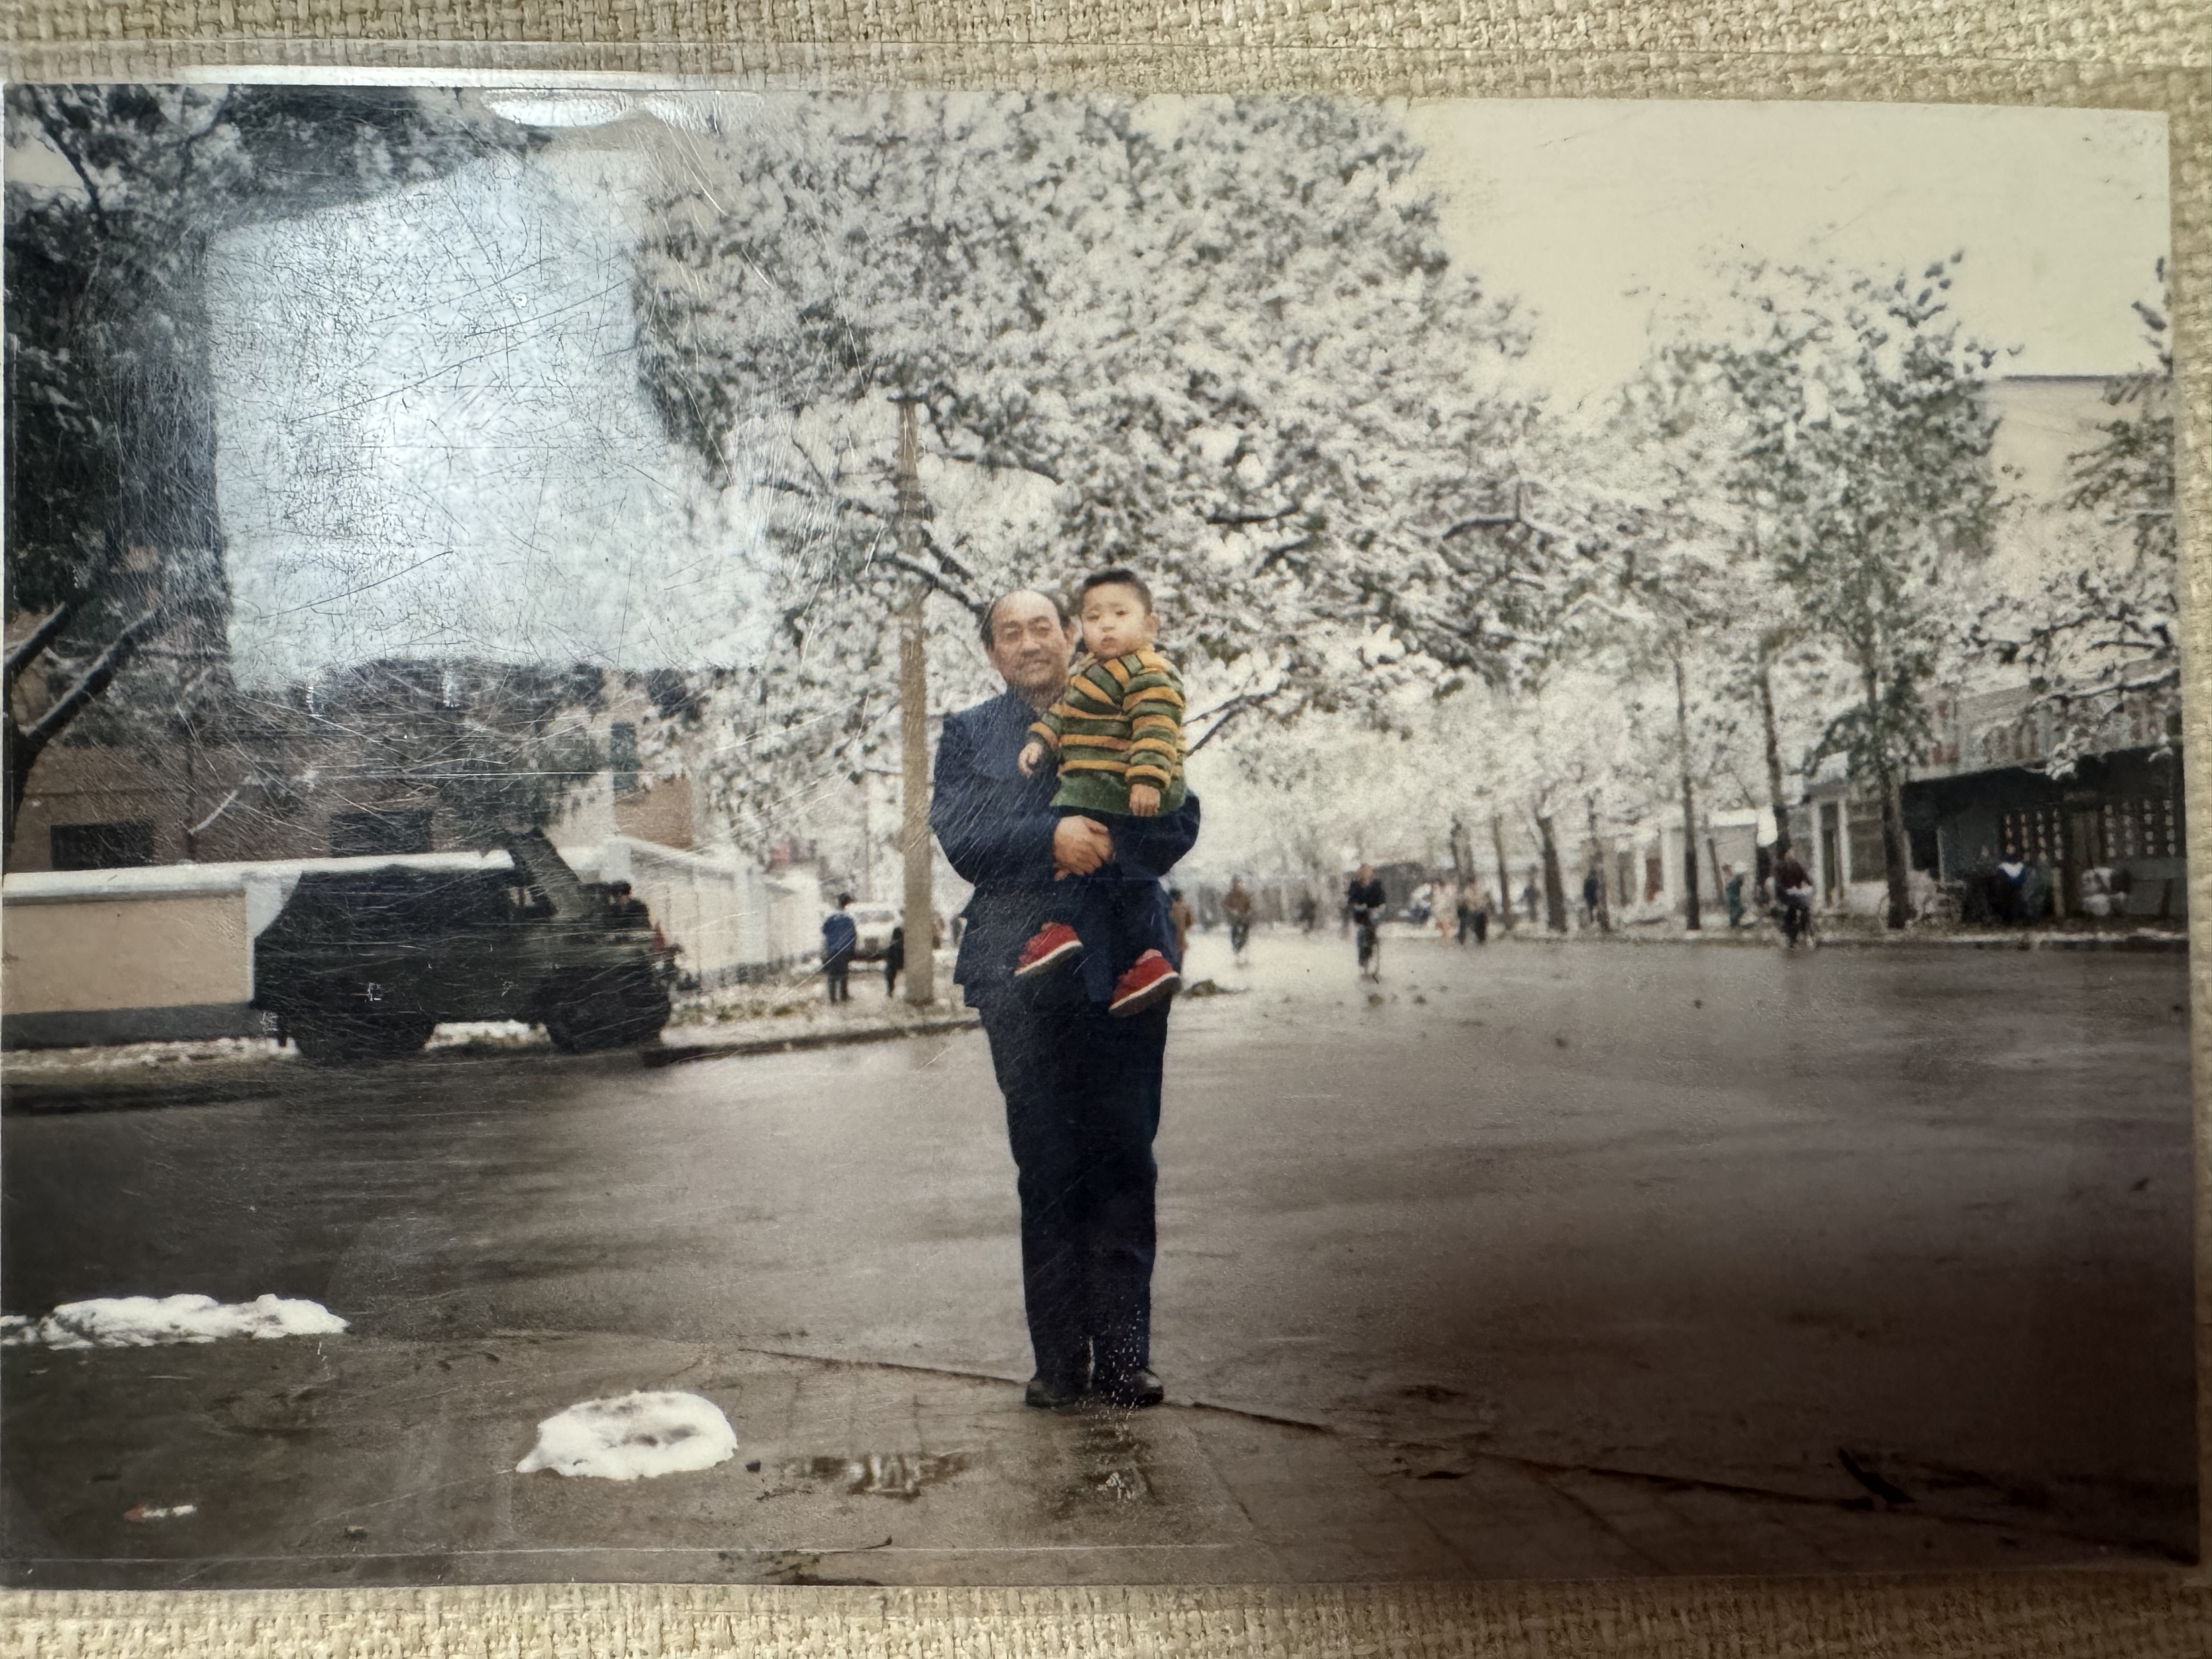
[{"xmin": 252, "ymin": 830, "xmax": 668, "ymax": 1059}]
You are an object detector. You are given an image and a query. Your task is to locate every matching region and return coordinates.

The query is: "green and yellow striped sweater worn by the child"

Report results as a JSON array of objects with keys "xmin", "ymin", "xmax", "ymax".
[{"xmin": 1029, "ymin": 648, "xmax": 1183, "ymax": 816}]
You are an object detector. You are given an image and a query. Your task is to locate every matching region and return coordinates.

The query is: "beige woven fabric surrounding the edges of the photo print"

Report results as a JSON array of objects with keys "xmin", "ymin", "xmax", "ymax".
[{"xmin": 0, "ymin": 0, "xmax": 2212, "ymax": 1659}]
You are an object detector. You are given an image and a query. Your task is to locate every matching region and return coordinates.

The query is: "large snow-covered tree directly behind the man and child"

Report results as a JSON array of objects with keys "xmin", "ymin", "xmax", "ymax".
[{"xmin": 637, "ymin": 95, "xmax": 1539, "ymax": 836}]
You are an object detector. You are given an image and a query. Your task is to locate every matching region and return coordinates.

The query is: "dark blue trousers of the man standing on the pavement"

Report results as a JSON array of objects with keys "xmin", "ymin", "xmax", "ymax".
[{"xmin": 982, "ymin": 995, "xmax": 1168, "ymax": 1387}]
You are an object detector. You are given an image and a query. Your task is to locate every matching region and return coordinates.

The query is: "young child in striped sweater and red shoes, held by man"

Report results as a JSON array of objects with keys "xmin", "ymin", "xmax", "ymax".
[{"xmin": 1013, "ymin": 568, "xmax": 1186, "ymax": 1018}]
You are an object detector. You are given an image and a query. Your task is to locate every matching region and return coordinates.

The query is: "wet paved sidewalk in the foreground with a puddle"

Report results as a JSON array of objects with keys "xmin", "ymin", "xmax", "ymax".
[{"xmin": 0, "ymin": 1329, "xmax": 2146, "ymax": 1588}]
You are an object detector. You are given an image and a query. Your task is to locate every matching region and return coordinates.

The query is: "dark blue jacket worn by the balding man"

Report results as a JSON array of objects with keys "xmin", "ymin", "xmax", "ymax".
[{"xmin": 929, "ymin": 690, "xmax": 1199, "ymax": 1009}]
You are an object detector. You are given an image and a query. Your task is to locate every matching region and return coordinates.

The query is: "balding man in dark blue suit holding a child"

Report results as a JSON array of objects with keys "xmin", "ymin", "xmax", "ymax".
[{"xmin": 929, "ymin": 593, "xmax": 1199, "ymax": 1409}]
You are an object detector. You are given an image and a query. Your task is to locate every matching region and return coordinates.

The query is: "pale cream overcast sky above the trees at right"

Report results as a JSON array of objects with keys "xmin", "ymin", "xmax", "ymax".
[{"xmin": 1407, "ymin": 99, "xmax": 2170, "ymax": 405}]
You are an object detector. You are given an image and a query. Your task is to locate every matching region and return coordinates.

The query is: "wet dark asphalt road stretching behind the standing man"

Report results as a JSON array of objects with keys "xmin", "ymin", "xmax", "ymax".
[{"xmin": 0, "ymin": 934, "xmax": 2194, "ymax": 1558}]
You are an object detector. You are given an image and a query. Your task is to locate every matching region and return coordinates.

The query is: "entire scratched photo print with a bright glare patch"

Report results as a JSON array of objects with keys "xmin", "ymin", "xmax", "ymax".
[{"xmin": 0, "ymin": 82, "xmax": 2197, "ymax": 1588}]
